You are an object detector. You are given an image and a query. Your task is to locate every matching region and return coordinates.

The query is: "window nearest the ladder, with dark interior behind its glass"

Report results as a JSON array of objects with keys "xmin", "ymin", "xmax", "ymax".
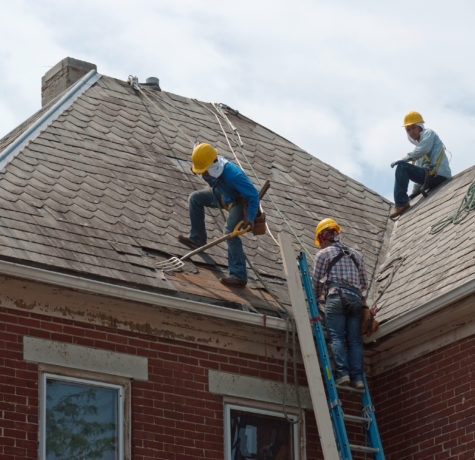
[{"xmin": 225, "ymin": 404, "xmax": 299, "ymax": 460}]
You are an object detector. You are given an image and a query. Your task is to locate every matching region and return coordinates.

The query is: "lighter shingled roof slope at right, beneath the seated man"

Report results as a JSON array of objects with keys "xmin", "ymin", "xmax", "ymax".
[{"xmin": 372, "ymin": 166, "xmax": 475, "ymax": 321}]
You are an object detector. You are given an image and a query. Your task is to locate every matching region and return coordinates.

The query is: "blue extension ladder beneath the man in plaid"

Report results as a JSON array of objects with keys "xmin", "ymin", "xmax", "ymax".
[{"xmin": 298, "ymin": 252, "xmax": 384, "ymax": 460}]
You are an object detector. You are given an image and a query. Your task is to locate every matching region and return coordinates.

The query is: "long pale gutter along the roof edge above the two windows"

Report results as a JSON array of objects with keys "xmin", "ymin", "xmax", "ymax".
[{"xmin": 0, "ymin": 261, "xmax": 286, "ymax": 331}]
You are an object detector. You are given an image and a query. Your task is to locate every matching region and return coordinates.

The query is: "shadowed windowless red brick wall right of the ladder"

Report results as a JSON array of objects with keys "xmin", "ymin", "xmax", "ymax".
[{"xmin": 372, "ymin": 337, "xmax": 475, "ymax": 460}]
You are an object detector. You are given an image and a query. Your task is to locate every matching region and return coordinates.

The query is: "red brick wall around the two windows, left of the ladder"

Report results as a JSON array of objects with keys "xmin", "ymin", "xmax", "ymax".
[{"xmin": 0, "ymin": 307, "xmax": 321, "ymax": 460}]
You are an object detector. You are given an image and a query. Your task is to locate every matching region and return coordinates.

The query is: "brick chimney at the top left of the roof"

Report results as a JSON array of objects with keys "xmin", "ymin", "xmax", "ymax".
[{"xmin": 41, "ymin": 57, "xmax": 97, "ymax": 105}]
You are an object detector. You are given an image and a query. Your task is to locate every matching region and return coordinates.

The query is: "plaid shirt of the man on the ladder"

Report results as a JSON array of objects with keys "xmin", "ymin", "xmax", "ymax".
[{"xmin": 312, "ymin": 242, "xmax": 368, "ymax": 301}]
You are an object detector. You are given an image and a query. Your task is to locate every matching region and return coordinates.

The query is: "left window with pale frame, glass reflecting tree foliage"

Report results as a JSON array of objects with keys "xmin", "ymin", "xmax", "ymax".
[{"xmin": 40, "ymin": 373, "xmax": 124, "ymax": 460}]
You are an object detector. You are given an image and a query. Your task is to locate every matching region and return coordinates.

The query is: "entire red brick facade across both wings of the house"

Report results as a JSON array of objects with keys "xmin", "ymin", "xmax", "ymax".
[{"xmin": 0, "ymin": 307, "xmax": 475, "ymax": 460}]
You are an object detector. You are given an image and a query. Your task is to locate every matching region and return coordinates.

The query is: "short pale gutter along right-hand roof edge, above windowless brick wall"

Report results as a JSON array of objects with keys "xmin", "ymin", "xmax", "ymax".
[{"xmin": 364, "ymin": 280, "xmax": 475, "ymax": 343}]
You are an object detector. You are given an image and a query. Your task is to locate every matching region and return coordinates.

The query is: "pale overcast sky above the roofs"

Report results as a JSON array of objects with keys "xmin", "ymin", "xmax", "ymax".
[{"xmin": 0, "ymin": 0, "xmax": 475, "ymax": 200}]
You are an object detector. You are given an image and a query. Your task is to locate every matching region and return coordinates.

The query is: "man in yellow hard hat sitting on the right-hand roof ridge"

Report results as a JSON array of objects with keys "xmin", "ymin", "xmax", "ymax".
[{"xmin": 389, "ymin": 112, "xmax": 452, "ymax": 218}]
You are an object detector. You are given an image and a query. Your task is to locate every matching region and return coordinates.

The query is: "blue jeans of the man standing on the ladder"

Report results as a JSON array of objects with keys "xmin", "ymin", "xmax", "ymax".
[{"xmin": 325, "ymin": 291, "xmax": 363, "ymax": 382}]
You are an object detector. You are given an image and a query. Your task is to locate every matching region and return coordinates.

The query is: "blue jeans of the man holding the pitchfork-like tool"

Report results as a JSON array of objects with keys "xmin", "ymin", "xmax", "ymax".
[{"xmin": 188, "ymin": 189, "xmax": 247, "ymax": 280}]
